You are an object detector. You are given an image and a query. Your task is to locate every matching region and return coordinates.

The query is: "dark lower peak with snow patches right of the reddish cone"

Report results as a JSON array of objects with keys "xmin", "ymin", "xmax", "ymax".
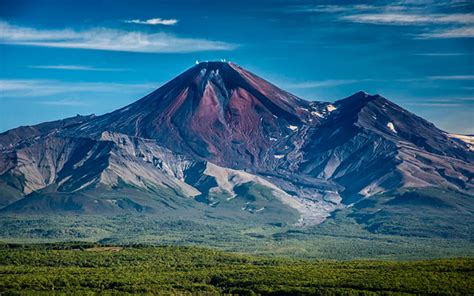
[{"xmin": 299, "ymin": 92, "xmax": 474, "ymax": 204}]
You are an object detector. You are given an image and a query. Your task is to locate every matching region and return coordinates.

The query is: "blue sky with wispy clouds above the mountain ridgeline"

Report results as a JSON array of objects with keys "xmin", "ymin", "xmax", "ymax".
[{"xmin": 0, "ymin": 0, "xmax": 474, "ymax": 134}]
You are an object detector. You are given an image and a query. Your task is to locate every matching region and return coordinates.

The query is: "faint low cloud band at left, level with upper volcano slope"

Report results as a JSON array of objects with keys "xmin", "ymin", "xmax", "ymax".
[{"xmin": 0, "ymin": 79, "xmax": 159, "ymax": 98}]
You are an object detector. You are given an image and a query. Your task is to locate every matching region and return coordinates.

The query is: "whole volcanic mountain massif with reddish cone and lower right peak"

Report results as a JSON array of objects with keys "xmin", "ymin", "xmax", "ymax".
[{"xmin": 0, "ymin": 62, "xmax": 474, "ymax": 233}]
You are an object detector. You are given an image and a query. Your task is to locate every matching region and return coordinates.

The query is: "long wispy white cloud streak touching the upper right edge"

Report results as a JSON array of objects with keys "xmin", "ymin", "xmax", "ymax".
[{"xmin": 340, "ymin": 13, "xmax": 474, "ymax": 25}]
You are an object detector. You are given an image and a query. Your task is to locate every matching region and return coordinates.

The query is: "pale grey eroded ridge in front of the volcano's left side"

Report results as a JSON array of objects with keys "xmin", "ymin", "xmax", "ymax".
[{"xmin": 0, "ymin": 132, "xmax": 304, "ymax": 223}]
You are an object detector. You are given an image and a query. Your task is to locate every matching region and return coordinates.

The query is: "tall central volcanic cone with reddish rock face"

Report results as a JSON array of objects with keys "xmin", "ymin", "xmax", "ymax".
[{"xmin": 78, "ymin": 62, "xmax": 318, "ymax": 168}]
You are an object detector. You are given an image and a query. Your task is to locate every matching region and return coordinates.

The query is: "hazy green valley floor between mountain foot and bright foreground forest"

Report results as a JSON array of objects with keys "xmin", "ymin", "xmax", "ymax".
[{"xmin": 0, "ymin": 215, "xmax": 474, "ymax": 261}]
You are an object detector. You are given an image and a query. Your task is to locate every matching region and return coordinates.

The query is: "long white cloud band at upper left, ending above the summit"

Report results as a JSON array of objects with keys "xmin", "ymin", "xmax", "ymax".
[{"xmin": 0, "ymin": 22, "xmax": 236, "ymax": 53}]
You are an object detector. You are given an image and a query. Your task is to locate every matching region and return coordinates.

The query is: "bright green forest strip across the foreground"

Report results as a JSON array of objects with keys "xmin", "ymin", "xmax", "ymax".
[{"xmin": 0, "ymin": 243, "xmax": 474, "ymax": 295}]
